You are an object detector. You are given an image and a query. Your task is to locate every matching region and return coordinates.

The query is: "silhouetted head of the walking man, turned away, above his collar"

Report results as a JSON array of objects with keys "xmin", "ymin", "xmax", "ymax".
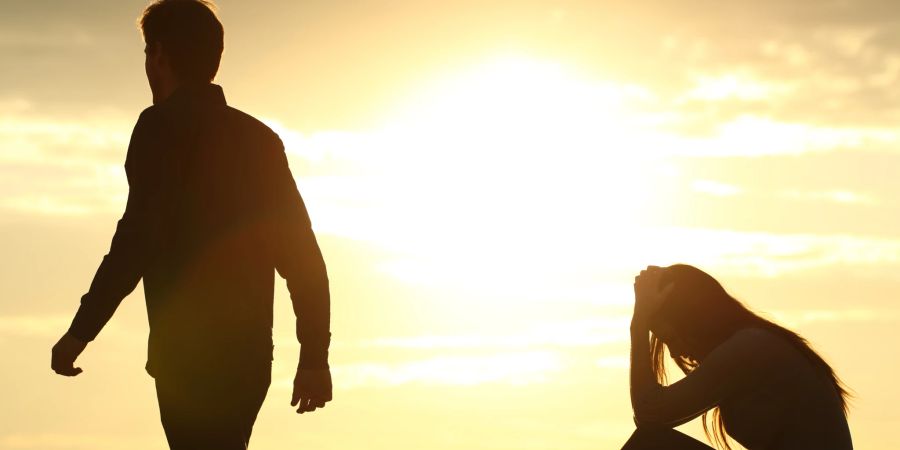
[{"xmin": 139, "ymin": 0, "xmax": 224, "ymax": 103}]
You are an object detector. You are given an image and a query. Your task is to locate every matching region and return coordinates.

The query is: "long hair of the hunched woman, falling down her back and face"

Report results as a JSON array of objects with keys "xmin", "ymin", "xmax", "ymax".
[{"xmin": 650, "ymin": 264, "xmax": 850, "ymax": 450}]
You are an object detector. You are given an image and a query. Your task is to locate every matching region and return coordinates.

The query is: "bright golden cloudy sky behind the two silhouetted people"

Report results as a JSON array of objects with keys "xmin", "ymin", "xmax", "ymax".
[{"xmin": 0, "ymin": 0, "xmax": 900, "ymax": 450}]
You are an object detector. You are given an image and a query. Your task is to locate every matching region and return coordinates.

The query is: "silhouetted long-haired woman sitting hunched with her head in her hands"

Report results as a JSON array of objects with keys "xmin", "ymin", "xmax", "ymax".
[{"xmin": 623, "ymin": 264, "xmax": 853, "ymax": 450}]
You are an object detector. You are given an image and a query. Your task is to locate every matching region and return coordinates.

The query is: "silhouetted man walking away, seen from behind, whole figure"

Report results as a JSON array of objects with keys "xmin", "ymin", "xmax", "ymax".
[{"xmin": 52, "ymin": 0, "xmax": 331, "ymax": 449}]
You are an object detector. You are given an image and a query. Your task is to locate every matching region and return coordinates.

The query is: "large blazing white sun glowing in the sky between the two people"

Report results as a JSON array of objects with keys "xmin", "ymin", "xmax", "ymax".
[{"xmin": 344, "ymin": 56, "xmax": 668, "ymax": 290}]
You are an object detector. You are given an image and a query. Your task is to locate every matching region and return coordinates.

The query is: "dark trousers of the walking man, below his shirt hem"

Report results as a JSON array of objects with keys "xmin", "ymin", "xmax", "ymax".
[{"xmin": 156, "ymin": 368, "xmax": 271, "ymax": 450}]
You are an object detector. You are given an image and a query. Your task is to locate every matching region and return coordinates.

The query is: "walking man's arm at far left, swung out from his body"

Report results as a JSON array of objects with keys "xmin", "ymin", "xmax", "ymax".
[{"xmin": 53, "ymin": 111, "xmax": 159, "ymax": 375}]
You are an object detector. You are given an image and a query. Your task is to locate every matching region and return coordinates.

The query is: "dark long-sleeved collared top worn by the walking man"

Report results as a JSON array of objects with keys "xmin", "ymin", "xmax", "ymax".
[{"xmin": 69, "ymin": 84, "xmax": 330, "ymax": 376}]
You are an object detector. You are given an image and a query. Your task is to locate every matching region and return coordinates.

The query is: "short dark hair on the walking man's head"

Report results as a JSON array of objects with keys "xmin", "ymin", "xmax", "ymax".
[{"xmin": 139, "ymin": 0, "xmax": 225, "ymax": 83}]
